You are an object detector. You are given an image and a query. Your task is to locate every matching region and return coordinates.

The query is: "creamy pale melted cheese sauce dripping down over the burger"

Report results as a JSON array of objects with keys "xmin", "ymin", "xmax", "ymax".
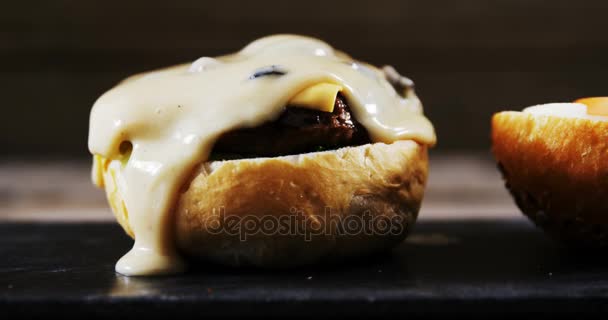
[{"xmin": 89, "ymin": 35, "xmax": 435, "ymax": 275}]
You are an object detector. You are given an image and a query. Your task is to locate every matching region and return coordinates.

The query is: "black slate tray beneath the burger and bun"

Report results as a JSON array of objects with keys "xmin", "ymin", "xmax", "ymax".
[{"xmin": 0, "ymin": 219, "xmax": 608, "ymax": 318}]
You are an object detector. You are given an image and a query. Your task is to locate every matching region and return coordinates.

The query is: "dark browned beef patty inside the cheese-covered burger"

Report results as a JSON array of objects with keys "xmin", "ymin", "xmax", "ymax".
[{"xmin": 212, "ymin": 94, "xmax": 370, "ymax": 158}]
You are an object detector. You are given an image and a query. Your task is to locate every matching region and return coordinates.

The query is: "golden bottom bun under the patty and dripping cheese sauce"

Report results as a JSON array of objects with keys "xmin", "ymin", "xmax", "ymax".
[{"xmin": 106, "ymin": 141, "xmax": 428, "ymax": 267}]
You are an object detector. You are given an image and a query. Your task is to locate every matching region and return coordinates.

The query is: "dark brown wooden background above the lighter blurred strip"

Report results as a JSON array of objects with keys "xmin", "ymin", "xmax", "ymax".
[{"xmin": 0, "ymin": 0, "xmax": 608, "ymax": 158}]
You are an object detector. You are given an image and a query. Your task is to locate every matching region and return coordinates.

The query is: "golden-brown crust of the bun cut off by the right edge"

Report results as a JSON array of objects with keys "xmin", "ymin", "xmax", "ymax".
[{"xmin": 492, "ymin": 111, "xmax": 608, "ymax": 246}]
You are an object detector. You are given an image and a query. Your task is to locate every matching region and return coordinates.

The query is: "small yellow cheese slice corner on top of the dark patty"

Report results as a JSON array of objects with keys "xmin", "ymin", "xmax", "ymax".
[{"xmin": 288, "ymin": 83, "xmax": 342, "ymax": 112}]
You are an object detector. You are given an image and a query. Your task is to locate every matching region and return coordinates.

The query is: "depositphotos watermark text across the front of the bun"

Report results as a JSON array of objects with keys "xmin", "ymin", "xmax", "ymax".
[{"xmin": 206, "ymin": 207, "xmax": 407, "ymax": 241}]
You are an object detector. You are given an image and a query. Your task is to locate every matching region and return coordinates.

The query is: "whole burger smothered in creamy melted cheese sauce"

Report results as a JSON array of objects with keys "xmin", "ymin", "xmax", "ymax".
[{"xmin": 88, "ymin": 35, "xmax": 435, "ymax": 275}]
